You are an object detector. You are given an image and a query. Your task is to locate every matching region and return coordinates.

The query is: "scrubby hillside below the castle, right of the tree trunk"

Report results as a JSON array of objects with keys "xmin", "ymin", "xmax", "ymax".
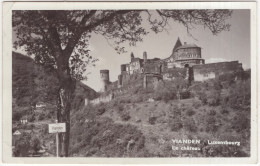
[{"xmin": 71, "ymin": 76, "xmax": 250, "ymax": 157}]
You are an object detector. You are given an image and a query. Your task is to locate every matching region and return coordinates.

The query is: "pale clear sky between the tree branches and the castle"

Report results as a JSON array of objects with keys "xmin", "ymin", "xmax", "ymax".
[{"xmin": 83, "ymin": 10, "xmax": 250, "ymax": 91}]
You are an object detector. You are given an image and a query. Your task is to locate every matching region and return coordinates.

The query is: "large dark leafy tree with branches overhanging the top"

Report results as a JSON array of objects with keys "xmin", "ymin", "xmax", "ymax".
[{"xmin": 12, "ymin": 10, "xmax": 232, "ymax": 156}]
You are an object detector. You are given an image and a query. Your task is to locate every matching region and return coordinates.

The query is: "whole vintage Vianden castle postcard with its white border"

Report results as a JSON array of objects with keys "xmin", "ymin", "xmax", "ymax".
[{"xmin": 4, "ymin": 2, "xmax": 257, "ymax": 164}]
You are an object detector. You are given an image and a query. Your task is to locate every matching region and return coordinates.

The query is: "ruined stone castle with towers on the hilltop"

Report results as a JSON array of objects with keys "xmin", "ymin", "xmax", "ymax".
[{"xmin": 86, "ymin": 38, "xmax": 243, "ymax": 104}]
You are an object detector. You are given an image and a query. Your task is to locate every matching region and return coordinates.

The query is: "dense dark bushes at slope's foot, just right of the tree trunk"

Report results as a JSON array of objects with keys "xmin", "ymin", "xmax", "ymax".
[{"xmin": 71, "ymin": 118, "xmax": 145, "ymax": 157}]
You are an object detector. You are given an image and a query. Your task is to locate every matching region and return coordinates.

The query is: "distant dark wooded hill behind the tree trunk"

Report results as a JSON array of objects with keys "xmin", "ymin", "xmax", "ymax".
[{"xmin": 12, "ymin": 52, "xmax": 98, "ymax": 106}]
